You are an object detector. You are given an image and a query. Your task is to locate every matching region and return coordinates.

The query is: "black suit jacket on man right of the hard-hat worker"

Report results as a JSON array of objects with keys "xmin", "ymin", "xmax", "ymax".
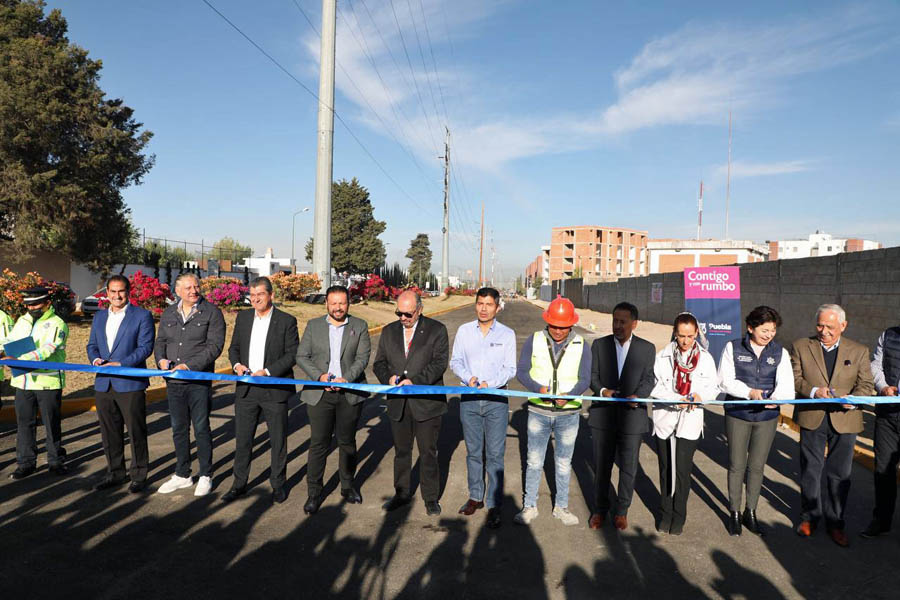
[{"xmin": 588, "ymin": 335, "xmax": 656, "ymax": 433}]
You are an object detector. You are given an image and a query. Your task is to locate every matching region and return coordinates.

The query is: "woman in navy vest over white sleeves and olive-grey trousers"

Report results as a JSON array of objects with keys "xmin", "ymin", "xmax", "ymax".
[{"xmin": 719, "ymin": 306, "xmax": 794, "ymax": 536}]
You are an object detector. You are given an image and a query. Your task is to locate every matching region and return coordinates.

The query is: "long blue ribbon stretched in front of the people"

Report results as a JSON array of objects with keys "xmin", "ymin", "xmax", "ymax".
[{"xmin": 0, "ymin": 358, "xmax": 884, "ymax": 404}]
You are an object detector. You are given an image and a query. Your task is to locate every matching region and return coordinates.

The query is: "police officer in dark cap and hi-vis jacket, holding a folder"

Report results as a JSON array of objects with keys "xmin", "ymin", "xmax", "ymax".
[{"xmin": 7, "ymin": 287, "xmax": 69, "ymax": 479}]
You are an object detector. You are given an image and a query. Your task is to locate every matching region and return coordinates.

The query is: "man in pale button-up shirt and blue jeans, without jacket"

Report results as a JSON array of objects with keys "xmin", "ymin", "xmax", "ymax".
[{"xmin": 450, "ymin": 287, "xmax": 516, "ymax": 529}]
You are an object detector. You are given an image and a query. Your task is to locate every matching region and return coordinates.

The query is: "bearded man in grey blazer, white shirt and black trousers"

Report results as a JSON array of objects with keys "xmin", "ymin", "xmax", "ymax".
[{"xmin": 297, "ymin": 285, "xmax": 372, "ymax": 514}]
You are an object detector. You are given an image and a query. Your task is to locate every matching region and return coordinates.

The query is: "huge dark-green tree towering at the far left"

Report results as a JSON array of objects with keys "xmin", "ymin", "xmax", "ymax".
[{"xmin": 0, "ymin": 0, "xmax": 154, "ymax": 271}]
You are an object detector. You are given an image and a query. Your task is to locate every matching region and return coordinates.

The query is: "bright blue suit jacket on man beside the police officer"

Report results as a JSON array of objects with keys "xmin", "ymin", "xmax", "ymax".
[{"xmin": 87, "ymin": 305, "xmax": 155, "ymax": 392}]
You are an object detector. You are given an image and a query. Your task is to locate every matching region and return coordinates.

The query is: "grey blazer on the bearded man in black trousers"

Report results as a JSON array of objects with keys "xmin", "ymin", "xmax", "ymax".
[{"xmin": 296, "ymin": 315, "xmax": 372, "ymax": 406}]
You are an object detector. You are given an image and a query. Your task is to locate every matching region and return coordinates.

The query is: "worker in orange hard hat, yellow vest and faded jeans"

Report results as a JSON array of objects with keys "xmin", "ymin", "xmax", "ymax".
[{"xmin": 514, "ymin": 296, "xmax": 591, "ymax": 525}]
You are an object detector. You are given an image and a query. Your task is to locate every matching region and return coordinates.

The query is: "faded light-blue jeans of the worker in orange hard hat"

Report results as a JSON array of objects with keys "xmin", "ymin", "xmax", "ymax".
[{"xmin": 525, "ymin": 410, "xmax": 581, "ymax": 508}]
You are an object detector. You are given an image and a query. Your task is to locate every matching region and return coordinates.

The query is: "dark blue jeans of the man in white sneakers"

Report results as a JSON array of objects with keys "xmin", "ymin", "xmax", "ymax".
[{"xmin": 166, "ymin": 381, "xmax": 212, "ymax": 477}]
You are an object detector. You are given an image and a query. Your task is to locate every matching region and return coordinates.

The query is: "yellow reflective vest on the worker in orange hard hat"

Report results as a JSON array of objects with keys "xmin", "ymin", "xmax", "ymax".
[{"xmin": 528, "ymin": 331, "xmax": 584, "ymax": 409}]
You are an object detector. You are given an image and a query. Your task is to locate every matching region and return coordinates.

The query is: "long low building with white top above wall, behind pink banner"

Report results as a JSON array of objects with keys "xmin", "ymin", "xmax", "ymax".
[{"xmin": 647, "ymin": 239, "xmax": 769, "ymax": 275}]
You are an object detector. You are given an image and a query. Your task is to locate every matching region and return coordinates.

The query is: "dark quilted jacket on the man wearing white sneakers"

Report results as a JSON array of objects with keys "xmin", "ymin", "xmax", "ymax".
[{"xmin": 153, "ymin": 299, "xmax": 225, "ymax": 382}]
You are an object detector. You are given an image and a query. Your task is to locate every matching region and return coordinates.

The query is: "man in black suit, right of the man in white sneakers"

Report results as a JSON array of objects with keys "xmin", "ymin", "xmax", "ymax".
[{"xmin": 222, "ymin": 277, "xmax": 298, "ymax": 504}]
